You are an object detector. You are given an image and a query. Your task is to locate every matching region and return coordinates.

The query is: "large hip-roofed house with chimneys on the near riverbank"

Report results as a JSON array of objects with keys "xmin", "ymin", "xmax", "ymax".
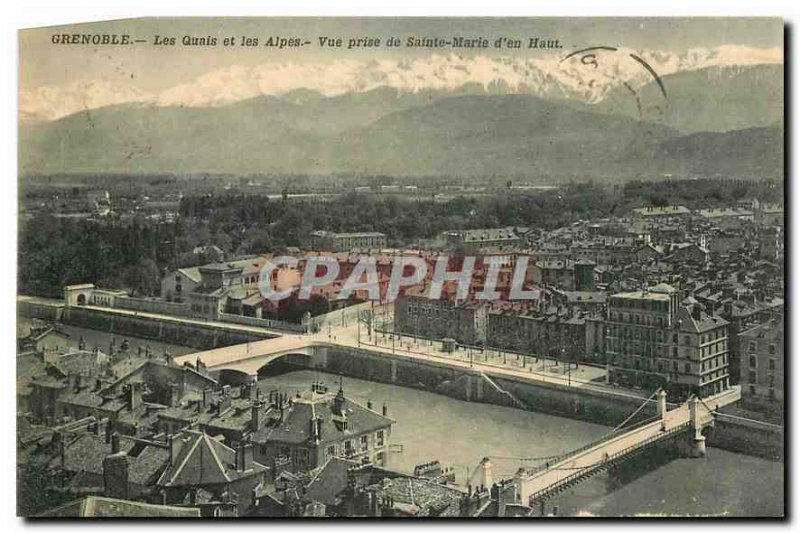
[{"xmin": 252, "ymin": 382, "xmax": 395, "ymax": 476}]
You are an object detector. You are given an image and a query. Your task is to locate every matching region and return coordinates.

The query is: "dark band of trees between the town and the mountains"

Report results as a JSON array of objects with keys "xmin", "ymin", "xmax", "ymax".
[{"xmin": 18, "ymin": 179, "xmax": 783, "ymax": 297}]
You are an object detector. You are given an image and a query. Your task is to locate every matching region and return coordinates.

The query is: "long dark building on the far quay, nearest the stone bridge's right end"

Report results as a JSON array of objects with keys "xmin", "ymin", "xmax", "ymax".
[{"xmin": 394, "ymin": 295, "xmax": 488, "ymax": 346}]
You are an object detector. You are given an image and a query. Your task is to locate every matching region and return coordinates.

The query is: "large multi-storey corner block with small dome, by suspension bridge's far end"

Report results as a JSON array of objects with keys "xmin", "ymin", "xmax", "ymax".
[{"xmin": 606, "ymin": 284, "xmax": 729, "ymax": 397}]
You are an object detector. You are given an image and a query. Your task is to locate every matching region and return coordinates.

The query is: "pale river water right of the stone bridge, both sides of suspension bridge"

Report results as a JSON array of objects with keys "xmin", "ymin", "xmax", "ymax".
[{"xmin": 261, "ymin": 370, "xmax": 784, "ymax": 516}]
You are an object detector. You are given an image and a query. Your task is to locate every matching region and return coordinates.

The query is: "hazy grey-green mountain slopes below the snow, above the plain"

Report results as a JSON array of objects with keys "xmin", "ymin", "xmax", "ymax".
[{"xmin": 19, "ymin": 64, "xmax": 783, "ymax": 181}]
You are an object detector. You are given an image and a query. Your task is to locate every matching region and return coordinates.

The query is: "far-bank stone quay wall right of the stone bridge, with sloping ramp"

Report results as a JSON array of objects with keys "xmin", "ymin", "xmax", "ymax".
[{"xmin": 293, "ymin": 346, "xmax": 784, "ymax": 461}]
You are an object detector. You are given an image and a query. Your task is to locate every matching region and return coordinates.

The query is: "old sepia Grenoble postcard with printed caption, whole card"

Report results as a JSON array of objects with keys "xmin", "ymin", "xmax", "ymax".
[{"xmin": 16, "ymin": 17, "xmax": 786, "ymax": 520}]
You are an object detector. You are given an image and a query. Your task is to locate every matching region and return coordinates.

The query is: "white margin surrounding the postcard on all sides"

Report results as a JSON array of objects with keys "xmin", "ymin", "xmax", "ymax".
[{"xmin": 0, "ymin": 0, "xmax": 800, "ymax": 531}]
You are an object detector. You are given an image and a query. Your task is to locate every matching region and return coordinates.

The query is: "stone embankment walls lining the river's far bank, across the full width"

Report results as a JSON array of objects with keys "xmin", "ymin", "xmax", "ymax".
[{"xmin": 18, "ymin": 299, "xmax": 784, "ymax": 461}]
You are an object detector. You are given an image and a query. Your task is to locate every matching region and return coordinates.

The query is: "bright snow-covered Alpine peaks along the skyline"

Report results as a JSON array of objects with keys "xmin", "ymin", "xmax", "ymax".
[{"xmin": 20, "ymin": 45, "xmax": 783, "ymax": 120}]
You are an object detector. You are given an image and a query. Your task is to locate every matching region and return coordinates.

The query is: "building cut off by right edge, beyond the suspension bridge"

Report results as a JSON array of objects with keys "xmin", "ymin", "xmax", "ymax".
[{"xmin": 739, "ymin": 317, "xmax": 784, "ymax": 411}]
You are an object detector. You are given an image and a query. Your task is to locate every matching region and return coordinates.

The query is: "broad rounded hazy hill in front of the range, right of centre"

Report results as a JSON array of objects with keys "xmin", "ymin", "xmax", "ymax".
[{"xmin": 328, "ymin": 95, "xmax": 675, "ymax": 176}]
